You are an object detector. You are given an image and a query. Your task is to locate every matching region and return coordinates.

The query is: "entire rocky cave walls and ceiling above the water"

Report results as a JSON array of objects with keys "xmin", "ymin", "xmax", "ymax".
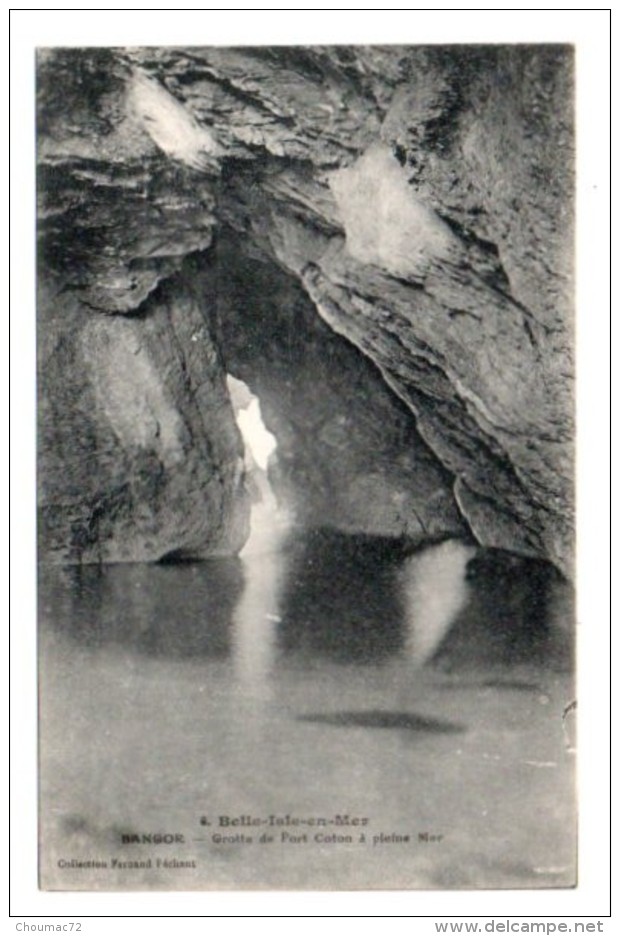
[{"xmin": 39, "ymin": 46, "xmax": 573, "ymax": 573}]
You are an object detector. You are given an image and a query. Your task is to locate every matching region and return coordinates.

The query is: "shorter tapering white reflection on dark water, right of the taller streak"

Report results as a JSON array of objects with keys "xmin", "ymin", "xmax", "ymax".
[{"xmin": 401, "ymin": 540, "xmax": 476, "ymax": 666}]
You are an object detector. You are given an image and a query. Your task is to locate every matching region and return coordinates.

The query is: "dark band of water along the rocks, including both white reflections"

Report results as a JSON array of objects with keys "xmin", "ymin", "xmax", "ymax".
[{"xmin": 40, "ymin": 532, "xmax": 571, "ymax": 697}]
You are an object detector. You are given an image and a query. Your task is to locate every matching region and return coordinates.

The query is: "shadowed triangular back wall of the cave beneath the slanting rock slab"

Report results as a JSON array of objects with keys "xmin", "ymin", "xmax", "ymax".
[{"xmin": 208, "ymin": 226, "xmax": 467, "ymax": 551}]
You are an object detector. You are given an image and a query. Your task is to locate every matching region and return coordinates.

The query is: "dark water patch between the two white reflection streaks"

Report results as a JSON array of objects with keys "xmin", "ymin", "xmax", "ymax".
[{"xmin": 278, "ymin": 529, "xmax": 405, "ymax": 664}]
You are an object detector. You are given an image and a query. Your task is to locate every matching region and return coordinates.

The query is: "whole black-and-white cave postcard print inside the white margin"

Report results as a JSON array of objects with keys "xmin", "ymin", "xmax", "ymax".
[{"xmin": 12, "ymin": 11, "xmax": 608, "ymax": 916}]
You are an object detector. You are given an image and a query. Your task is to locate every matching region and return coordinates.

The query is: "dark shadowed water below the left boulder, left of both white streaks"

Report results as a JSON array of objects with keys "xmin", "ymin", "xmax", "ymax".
[{"xmin": 39, "ymin": 559, "xmax": 244, "ymax": 658}]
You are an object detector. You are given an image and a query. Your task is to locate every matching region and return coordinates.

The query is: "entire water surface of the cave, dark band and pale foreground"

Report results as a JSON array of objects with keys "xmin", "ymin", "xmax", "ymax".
[{"xmin": 39, "ymin": 532, "xmax": 574, "ymax": 887}]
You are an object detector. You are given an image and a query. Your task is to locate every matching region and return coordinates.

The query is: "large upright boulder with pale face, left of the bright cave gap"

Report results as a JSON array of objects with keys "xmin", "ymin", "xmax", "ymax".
[{"xmin": 39, "ymin": 266, "xmax": 249, "ymax": 562}]
